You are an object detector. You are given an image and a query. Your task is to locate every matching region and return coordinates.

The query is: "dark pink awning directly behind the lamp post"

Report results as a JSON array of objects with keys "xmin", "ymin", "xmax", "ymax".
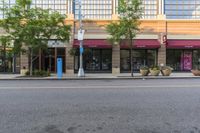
[{"xmin": 73, "ymin": 39, "xmax": 112, "ymax": 48}]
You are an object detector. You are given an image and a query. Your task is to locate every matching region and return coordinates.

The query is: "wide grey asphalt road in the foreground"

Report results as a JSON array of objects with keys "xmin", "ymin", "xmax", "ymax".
[{"xmin": 0, "ymin": 79, "xmax": 200, "ymax": 133}]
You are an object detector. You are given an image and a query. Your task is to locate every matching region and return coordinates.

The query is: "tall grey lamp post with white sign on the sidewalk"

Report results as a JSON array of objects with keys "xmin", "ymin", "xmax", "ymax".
[{"xmin": 78, "ymin": 0, "xmax": 85, "ymax": 77}]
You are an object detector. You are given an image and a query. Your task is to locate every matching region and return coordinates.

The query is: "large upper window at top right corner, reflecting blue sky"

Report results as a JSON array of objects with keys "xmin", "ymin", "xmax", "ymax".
[{"xmin": 165, "ymin": 0, "xmax": 200, "ymax": 19}]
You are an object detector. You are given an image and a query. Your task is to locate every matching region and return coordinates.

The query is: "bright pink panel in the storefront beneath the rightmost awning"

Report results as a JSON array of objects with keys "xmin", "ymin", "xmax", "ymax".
[{"xmin": 181, "ymin": 51, "xmax": 192, "ymax": 71}]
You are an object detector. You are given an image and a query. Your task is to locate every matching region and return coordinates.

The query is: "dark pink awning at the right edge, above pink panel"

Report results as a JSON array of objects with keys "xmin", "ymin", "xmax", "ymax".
[{"xmin": 167, "ymin": 40, "xmax": 200, "ymax": 49}]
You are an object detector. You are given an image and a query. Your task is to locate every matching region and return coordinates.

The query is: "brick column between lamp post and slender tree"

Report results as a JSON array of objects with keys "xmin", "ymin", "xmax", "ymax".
[{"xmin": 112, "ymin": 44, "xmax": 120, "ymax": 75}]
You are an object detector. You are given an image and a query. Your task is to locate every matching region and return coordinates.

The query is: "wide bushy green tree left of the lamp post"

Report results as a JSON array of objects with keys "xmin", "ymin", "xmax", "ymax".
[{"xmin": 0, "ymin": 0, "xmax": 71, "ymax": 75}]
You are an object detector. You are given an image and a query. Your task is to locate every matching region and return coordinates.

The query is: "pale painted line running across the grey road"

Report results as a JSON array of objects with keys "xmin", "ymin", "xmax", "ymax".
[{"xmin": 0, "ymin": 85, "xmax": 200, "ymax": 90}]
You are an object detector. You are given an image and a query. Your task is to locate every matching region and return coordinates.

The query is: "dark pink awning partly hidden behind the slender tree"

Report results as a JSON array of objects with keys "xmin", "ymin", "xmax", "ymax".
[{"xmin": 121, "ymin": 39, "xmax": 160, "ymax": 49}]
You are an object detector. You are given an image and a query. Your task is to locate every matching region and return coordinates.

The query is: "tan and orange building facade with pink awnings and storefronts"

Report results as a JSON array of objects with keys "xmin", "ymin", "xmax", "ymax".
[{"xmin": 0, "ymin": 0, "xmax": 200, "ymax": 74}]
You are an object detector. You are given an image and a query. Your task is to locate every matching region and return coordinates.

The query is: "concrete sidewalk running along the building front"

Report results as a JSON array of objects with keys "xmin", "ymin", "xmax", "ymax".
[{"xmin": 0, "ymin": 72, "xmax": 200, "ymax": 80}]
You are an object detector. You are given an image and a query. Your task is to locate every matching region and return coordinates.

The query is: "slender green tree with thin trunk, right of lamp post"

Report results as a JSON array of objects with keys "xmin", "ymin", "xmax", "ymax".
[{"xmin": 106, "ymin": 0, "xmax": 142, "ymax": 77}]
